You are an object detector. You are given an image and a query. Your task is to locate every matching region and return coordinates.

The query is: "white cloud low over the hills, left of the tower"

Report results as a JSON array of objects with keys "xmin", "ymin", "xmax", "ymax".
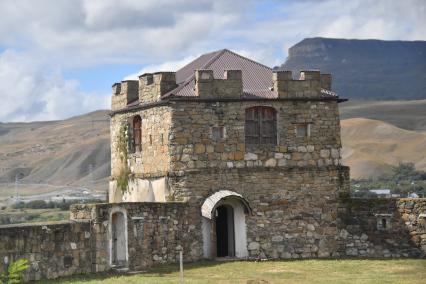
[{"xmin": 0, "ymin": 50, "xmax": 109, "ymax": 121}]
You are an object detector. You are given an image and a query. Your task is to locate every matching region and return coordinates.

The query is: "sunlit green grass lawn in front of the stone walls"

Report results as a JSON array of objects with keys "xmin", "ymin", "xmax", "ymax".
[{"xmin": 42, "ymin": 259, "xmax": 426, "ymax": 284}]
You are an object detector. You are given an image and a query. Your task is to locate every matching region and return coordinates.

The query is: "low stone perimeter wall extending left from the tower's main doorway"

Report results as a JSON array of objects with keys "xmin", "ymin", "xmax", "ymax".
[{"xmin": 0, "ymin": 203, "xmax": 198, "ymax": 281}]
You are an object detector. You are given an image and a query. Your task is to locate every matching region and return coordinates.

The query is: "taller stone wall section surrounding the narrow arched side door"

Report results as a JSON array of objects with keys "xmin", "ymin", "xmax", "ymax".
[{"xmin": 71, "ymin": 202, "xmax": 202, "ymax": 270}]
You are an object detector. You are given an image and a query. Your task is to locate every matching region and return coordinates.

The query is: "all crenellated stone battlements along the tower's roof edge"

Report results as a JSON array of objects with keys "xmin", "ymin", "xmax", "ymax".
[{"xmin": 111, "ymin": 69, "xmax": 338, "ymax": 111}]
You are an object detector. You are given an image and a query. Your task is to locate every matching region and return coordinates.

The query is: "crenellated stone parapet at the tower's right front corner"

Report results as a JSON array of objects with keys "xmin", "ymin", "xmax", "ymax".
[{"xmin": 272, "ymin": 71, "xmax": 331, "ymax": 98}]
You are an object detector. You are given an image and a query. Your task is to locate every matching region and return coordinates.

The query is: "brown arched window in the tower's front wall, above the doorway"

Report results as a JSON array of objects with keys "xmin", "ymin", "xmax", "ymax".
[{"xmin": 245, "ymin": 106, "xmax": 277, "ymax": 145}]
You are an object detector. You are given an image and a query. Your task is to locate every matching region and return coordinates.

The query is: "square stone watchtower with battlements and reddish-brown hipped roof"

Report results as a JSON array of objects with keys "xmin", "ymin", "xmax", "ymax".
[{"xmin": 109, "ymin": 50, "xmax": 349, "ymax": 258}]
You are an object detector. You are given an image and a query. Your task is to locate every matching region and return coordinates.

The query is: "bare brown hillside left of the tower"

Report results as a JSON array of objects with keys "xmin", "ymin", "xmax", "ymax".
[{"xmin": 0, "ymin": 110, "xmax": 110, "ymax": 190}]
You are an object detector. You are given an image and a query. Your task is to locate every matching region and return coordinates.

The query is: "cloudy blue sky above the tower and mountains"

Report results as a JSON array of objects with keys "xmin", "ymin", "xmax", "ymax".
[{"xmin": 0, "ymin": 0, "xmax": 426, "ymax": 122}]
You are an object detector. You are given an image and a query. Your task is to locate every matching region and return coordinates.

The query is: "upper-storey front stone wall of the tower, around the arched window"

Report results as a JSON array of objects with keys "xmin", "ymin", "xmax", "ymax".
[{"xmin": 170, "ymin": 100, "xmax": 341, "ymax": 171}]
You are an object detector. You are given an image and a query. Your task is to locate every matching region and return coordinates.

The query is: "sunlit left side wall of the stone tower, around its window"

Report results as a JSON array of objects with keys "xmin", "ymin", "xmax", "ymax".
[{"xmin": 109, "ymin": 106, "xmax": 171, "ymax": 202}]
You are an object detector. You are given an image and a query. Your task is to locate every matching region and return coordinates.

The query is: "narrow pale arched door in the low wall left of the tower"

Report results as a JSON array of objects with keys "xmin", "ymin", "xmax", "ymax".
[{"xmin": 109, "ymin": 209, "xmax": 128, "ymax": 267}]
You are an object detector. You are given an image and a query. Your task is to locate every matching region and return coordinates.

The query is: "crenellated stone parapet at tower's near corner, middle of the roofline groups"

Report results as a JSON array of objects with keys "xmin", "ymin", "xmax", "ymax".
[{"xmin": 195, "ymin": 70, "xmax": 243, "ymax": 99}]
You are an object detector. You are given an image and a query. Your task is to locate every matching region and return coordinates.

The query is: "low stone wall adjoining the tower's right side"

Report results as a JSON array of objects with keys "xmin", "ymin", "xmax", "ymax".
[{"xmin": 340, "ymin": 198, "xmax": 426, "ymax": 257}]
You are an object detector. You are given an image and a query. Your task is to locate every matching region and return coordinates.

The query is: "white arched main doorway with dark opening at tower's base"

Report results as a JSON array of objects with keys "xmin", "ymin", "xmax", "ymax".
[{"xmin": 201, "ymin": 190, "xmax": 251, "ymax": 258}]
